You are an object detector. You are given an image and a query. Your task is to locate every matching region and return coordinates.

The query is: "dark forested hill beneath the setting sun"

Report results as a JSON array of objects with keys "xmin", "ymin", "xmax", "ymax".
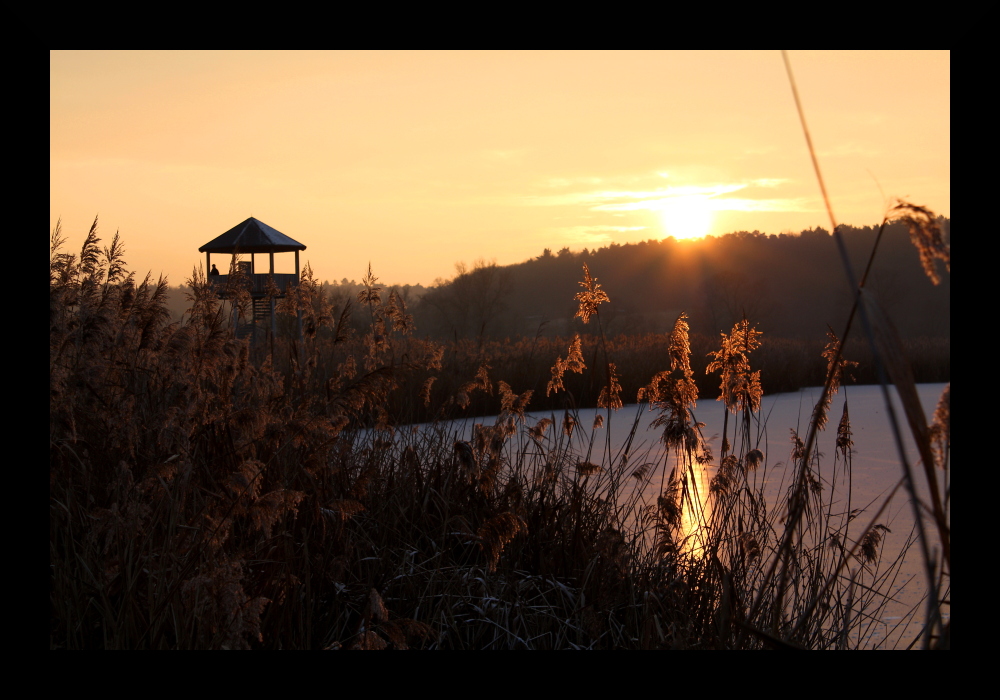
[{"xmin": 411, "ymin": 219, "xmax": 951, "ymax": 338}]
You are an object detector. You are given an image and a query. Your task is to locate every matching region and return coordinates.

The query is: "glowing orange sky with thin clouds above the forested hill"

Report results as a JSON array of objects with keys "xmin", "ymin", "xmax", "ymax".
[{"xmin": 49, "ymin": 51, "xmax": 951, "ymax": 285}]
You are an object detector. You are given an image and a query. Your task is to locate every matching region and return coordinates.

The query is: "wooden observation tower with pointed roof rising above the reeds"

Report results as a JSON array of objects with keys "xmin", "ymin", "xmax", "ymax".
[{"xmin": 198, "ymin": 216, "xmax": 306, "ymax": 336}]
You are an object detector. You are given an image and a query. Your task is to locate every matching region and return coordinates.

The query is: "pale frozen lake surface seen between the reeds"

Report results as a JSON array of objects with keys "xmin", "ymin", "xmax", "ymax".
[{"xmin": 418, "ymin": 384, "xmax": 950, "ymax": 648}]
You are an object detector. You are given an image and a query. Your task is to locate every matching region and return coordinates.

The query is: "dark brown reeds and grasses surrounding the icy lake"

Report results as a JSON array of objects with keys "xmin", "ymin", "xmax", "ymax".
[{"xmin": 49, "ymin": 196, "xmax": 950, "ymax": 649}]
